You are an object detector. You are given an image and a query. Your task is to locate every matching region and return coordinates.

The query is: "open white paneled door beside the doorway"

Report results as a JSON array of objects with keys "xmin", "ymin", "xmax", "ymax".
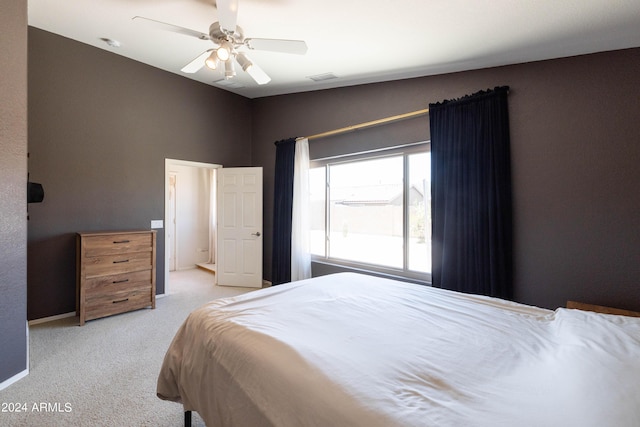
[{"xmin": 216, "ymin": 167, "xmax": 262, "ymax": 288}]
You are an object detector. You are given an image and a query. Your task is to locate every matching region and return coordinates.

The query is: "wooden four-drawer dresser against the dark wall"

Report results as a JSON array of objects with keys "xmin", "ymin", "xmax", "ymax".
[{"xmin": 76, "ymin": 230, "xmax": 156, "ymax": 326}]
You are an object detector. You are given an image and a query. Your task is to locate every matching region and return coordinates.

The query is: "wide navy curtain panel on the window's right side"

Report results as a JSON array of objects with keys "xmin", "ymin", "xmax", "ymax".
[{"xmin": 429, "ymin": 87, "xmax": 513, "ymax": 299}]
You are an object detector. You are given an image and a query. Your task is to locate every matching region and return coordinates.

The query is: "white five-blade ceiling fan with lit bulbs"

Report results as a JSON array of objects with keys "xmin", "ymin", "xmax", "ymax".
[{"xmin": 133, "ymin": 0, "xmax": 307, "ymax": 85}]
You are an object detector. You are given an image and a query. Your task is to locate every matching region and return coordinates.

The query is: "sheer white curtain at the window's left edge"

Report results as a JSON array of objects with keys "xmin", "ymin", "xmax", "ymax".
[{"xmin": 291, "ymin": 138, "xmax": 311, "ymax": 281}]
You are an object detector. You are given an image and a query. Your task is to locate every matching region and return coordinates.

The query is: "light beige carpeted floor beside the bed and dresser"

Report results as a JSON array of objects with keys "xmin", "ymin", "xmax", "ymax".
[{"xmin": 0, "ymin": 269, "xmax": 251, "ymax": 427}]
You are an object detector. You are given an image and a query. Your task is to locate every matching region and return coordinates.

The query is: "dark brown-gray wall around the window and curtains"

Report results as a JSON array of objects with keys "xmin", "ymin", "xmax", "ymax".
[{"xmin": 252, "ymin": 49, "xmax": 640, "ymax": 310}]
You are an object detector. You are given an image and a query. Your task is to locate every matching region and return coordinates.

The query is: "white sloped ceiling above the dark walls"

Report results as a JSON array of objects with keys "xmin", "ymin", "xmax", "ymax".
[{"xmin": 28, "ymin": 0, "xmax": 640, "ymax": 98}]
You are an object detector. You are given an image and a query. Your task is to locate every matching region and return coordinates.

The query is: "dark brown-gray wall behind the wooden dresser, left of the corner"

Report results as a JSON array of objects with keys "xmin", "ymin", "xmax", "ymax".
[{"xmin": 28, "ymin": 28, "xmax": 251, "ymax": 319}]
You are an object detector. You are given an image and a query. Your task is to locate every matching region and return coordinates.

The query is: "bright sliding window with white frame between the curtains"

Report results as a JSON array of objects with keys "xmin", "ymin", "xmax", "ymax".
[{"xmin": 309, "ymin": 144, "xmax": 431, "ymax": 280}]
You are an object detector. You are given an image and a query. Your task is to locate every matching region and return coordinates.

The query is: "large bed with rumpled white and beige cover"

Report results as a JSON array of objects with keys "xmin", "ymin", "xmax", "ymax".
[{"xmin": 157, "ymin": 273, "xmax": 640, "ymax": 427}]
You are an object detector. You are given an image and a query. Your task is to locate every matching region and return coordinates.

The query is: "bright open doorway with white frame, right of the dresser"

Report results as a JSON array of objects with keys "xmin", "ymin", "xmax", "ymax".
[{"xmin": 164, "ymin": 159, "xmax": 222, "ymax": 295}]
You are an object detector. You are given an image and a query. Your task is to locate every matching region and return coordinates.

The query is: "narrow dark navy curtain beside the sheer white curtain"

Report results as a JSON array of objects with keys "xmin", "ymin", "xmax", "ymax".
[{"xmin": 271, "ymin": 138, "xmax": 296, "ymax": 285}]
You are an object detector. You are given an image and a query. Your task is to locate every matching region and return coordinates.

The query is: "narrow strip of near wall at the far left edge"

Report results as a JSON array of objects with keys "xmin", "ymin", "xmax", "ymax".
[{"xmin": 0, "ymin": 0, "xmax": 28, "ymax": 383}]
